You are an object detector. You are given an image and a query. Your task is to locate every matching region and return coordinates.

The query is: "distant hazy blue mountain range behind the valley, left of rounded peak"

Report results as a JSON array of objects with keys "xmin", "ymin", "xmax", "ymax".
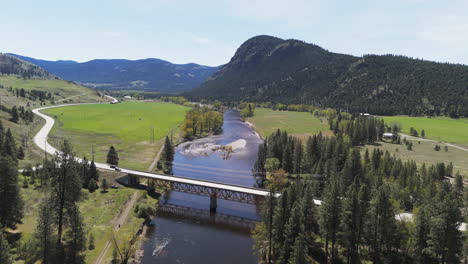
[{"xmin": 7, "ymin": 54, "xmax": 218, "ymax": 92}]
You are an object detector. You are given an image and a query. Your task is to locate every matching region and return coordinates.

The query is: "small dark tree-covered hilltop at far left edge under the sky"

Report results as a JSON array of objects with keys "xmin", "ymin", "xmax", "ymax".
[{"xmin": 0, "ymin": 53, "xmax": 56, "ymax": 79}]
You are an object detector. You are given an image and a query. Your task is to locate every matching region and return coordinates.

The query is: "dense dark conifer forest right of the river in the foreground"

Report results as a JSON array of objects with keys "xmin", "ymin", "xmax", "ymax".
[{"xmin": 253, "ymin": 115, "xmax": 468, "ymax": 264}]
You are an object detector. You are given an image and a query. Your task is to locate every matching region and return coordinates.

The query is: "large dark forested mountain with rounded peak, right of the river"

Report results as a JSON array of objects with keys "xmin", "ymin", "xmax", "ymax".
[{"xmin": 185, "ymin": 36, "xmax": 468, "ymax": 116}]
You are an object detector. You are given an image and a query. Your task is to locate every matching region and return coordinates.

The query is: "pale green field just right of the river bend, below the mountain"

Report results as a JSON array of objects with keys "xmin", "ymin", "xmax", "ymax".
[{"xmin": 248, "ymin": 108, "xmax": 331, "ymax": 140}]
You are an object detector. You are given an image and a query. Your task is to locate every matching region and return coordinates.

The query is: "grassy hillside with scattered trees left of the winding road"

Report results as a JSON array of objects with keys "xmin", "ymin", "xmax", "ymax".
[{"xmin": 0, "ymin": 54, "xmax": 106, "ymax": 167}]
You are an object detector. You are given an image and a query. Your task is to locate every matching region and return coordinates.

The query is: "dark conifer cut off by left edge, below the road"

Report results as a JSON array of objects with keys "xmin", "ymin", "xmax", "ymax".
[{"xmin": 0, "ymin": 156, "xmax": 23, "ymax": 228}]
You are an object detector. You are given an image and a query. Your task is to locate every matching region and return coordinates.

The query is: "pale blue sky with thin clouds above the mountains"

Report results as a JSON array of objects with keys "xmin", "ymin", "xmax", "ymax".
[{"xmin": 0, "ymin": 0, "xmax": 468, "ymax": 66}]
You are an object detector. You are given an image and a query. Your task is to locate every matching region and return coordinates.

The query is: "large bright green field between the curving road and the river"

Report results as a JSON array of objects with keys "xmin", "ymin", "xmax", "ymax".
[{"xmin": 44, "ymin": 101, "xmax": 189, "ymax": 170}]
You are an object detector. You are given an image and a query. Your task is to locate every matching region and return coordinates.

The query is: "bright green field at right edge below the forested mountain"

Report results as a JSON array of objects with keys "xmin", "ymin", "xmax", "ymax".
[{"xmin": 384, "ymin": 116, "xmax": 468, "ymax": 144}]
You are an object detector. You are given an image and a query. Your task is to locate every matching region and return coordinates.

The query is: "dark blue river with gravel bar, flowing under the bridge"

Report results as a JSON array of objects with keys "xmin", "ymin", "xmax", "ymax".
[{"xmin": 141, "ymin": 110, "xmax": 262, "ymax": 264}]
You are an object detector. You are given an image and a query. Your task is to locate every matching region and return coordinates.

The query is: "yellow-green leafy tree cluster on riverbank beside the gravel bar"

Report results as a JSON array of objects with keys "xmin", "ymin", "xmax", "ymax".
[{"xmin": 182, "ymin": 107, "xmax": 223, "ymax": 139}]
